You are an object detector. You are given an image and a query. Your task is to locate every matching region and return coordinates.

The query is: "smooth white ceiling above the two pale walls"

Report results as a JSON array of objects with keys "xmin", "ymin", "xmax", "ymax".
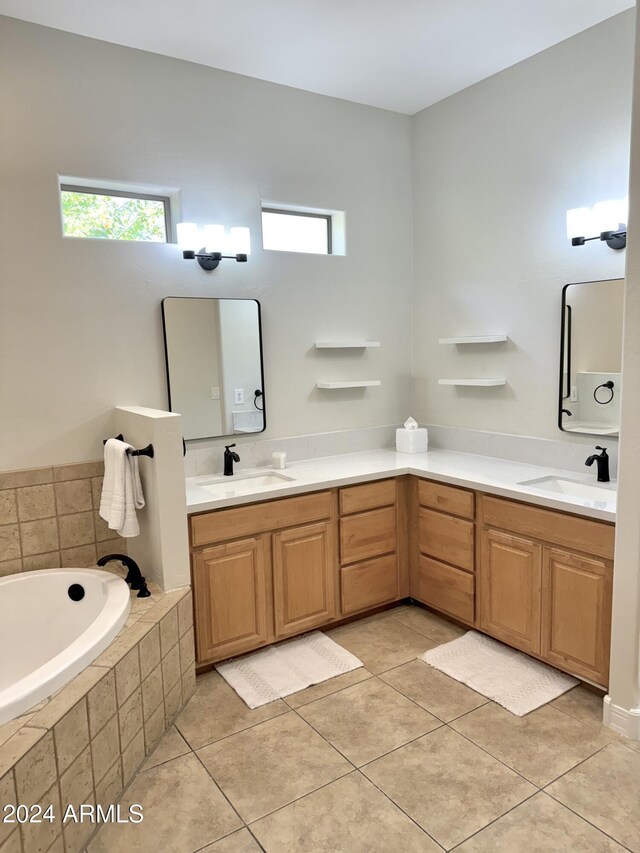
[{"xmin": 0, "ymin": 0, "xmax": 634, "ymax": 114}]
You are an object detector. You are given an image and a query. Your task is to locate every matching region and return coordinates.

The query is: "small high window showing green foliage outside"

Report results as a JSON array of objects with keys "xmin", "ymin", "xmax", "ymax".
[{"xmin": 60, "ymin": 184, "xmax": 171, "ymax": 243}]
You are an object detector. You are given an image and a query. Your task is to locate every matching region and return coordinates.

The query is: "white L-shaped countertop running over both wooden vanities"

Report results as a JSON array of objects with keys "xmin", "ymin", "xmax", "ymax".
[{"xmin": 186, "ymin": 450, "xmax": 616, "ymax": 522}]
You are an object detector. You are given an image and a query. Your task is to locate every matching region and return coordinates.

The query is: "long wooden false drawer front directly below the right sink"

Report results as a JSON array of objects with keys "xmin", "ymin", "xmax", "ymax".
[{"xmin": 480, "ymin": 495, "xmax": 615, "ymax": 560}]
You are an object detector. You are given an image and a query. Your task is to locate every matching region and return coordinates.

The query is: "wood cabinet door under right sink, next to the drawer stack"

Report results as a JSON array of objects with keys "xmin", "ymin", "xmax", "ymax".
[{"xmin": 479, "ymin": 530, "xmax": 542, "ymax": 654}]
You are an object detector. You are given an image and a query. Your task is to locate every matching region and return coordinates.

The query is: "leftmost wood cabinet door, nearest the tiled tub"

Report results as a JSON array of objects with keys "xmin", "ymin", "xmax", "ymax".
[{"xmin": 193, "ymin": 537, "xmax": 268, "ymax": 663}]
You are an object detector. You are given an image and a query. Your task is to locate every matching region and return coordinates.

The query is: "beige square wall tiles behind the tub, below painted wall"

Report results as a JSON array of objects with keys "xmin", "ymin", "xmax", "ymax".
[{"xmin": 0, "ymin": 461, "xmax": 126, "ymax": 575}]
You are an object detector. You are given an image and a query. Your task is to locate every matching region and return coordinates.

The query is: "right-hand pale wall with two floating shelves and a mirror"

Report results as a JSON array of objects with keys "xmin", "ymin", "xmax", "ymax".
[{"xmin": 413, "ymin": 10, "xmax": 634, "ymax": 441}]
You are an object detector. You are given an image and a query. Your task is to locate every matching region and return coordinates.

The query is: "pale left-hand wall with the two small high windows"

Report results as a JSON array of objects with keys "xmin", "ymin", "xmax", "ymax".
[{"xmin": 0, "ymin": 18, "xmax": 412, "ymax": 470}]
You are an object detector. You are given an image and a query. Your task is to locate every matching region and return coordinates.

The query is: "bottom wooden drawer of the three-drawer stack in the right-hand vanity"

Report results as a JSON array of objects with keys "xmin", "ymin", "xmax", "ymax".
[{"xmin": 417, "ymin": 554, "xmax": 475, "ymax": 623}]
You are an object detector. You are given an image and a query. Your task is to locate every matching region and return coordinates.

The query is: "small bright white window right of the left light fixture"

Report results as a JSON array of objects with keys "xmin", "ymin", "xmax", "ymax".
[{"xmin": 262, "ymin": 207, "xmax": 332, "ymax": 255}]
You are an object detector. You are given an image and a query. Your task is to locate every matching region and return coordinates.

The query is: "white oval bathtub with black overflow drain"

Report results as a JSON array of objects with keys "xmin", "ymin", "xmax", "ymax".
[{"xmin": 0, "ymin": 569, "xmax": 131, "ymax": 724}]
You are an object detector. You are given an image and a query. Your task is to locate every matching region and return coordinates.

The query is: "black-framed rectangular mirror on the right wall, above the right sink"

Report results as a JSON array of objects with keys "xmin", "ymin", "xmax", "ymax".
[{"xmin": 558, "ymin": 278, "xmax": 624, "ymax": 435}]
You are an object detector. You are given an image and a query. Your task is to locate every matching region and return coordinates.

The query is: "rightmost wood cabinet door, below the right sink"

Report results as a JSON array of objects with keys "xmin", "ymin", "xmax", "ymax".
[{"xmin": 542, "ymin": 548, "xmax": 613, "ymax": 687}]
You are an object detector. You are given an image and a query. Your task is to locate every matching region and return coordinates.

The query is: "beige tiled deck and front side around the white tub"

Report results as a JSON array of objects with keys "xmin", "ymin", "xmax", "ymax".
[{"xmin": 0, "ymin": 585, "xmax": 195, "ymax": 853}]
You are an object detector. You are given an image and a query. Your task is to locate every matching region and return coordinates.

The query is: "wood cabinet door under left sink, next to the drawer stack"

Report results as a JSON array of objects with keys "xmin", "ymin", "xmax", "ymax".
[{"xmin": 273, "ymin": 522, "xmax": 337, "ymax": 639}]
